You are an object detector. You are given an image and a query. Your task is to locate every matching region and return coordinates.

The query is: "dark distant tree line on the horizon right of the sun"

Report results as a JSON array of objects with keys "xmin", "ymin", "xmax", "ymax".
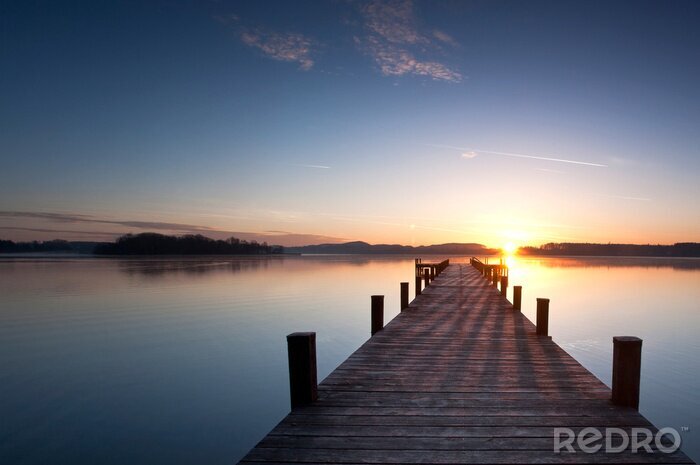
[{"xmin": 518, "ymin": 242, "xmax": 700, "ymax": 257}]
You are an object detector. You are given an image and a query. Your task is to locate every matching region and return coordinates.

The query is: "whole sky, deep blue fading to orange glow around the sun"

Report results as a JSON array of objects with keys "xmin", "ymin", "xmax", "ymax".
[{"xmin": 0, "ymin": 0, "xmax": 700, "ymax": 247}]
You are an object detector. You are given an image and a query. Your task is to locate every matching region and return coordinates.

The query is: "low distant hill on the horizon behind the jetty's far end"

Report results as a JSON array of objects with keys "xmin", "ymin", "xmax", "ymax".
[{"xmin": 284, "ymin": 241, "xmax": 499, "ymax": 255}]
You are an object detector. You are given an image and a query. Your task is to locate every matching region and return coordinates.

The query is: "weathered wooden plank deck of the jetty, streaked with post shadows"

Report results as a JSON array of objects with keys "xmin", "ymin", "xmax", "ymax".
[{"xmin": 241, "ymin": 263, "xmax": 693, "ymax": 465}]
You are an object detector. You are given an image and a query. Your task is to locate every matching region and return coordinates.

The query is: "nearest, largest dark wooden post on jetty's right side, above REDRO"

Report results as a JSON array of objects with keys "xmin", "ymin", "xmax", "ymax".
[{"xmin": 612, "ymin": 336, "xmax": 642, "ymax": 410}]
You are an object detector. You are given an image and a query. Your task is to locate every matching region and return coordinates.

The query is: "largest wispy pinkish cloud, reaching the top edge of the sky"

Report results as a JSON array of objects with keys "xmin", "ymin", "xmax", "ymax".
[{"xmin": 355, "ymin": 0, "xmax": 462, "ymax": 82}]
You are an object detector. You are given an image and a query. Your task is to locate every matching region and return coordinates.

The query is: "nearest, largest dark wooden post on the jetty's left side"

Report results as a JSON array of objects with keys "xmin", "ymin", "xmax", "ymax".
[{"xmin": 287, "ymin": 333, "xmax": 318, "ymax": 410}]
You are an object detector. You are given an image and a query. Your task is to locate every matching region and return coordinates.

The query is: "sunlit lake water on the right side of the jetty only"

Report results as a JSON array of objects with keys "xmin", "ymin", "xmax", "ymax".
[{"xmin": 500, "ymin": 257, "xmax": 700, "ymax": 460}]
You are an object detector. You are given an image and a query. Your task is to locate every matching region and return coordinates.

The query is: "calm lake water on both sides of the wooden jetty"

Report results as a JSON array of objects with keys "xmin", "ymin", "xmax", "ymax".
[{"xmin": 0, "ymin": 256, "xmax": 700, "ymax": 464}]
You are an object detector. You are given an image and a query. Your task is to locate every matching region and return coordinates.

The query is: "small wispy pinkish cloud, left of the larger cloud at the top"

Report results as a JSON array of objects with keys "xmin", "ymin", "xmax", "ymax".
[{"xmin": 241, "ymin": 29, "xmax": 314, "ymax": 71}]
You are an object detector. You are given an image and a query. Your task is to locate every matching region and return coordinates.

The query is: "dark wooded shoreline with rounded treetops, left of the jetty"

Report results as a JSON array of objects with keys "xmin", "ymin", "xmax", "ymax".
[{"xmin": 94, "ymin": 233, "xmax": 284, "ymax": 255}]
